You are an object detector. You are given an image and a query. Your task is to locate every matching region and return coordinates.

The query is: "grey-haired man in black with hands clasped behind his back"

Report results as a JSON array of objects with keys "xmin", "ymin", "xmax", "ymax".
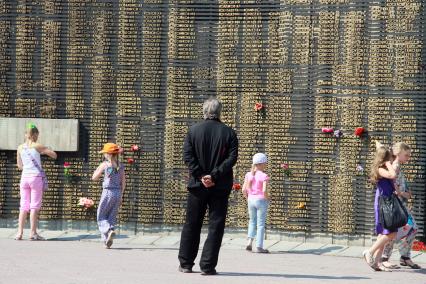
[{"xmin": 179, "ymin": 98, "xmax": 238, "ymax": 275}]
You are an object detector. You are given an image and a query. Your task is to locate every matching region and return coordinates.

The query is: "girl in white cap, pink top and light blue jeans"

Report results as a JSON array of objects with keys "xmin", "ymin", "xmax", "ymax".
[{"xmin": 243, "ymin": 153, "xmax": 269, "ymax": 253}]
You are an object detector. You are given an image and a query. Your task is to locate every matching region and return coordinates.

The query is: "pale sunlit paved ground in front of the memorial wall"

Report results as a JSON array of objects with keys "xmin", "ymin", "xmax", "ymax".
[{"xmin": 0, "ymin": 229, "xmax": 426, "ymax": 284}]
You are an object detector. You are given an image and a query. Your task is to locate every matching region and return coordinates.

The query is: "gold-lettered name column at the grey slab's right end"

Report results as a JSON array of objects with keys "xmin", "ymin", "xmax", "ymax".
[{"xmin": 66, "ymin": 0, "xmax": 90, "ymax": 220}]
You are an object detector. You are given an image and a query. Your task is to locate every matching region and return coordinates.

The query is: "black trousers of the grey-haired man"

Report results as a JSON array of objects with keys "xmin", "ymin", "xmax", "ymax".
[{"xmin": 178, "ymin": 188, "xmax": 229, "ymax": 272}]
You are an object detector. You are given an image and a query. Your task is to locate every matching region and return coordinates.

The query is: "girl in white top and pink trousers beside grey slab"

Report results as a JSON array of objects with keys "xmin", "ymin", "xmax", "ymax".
[{"xmin": 15, "ymin": 123, "xmax": 57, "ymax": 241}]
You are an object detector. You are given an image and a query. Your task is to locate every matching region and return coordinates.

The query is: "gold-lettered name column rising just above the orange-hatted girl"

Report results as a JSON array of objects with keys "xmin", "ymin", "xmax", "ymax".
[{"xmin": 87, "ymin": 2, "xmax": 115, "ymax": 221}]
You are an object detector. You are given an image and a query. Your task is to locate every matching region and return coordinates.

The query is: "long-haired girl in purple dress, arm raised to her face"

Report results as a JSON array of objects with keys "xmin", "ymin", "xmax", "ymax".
[{"xmin": 363, "ymin": 141, "xmax": 397, "ymax": 271}]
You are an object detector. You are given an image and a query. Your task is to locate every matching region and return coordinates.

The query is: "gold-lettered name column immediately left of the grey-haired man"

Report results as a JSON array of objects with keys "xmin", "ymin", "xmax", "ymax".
[{"xmin": 164, "ymin": 1, "xmax": 196, "ymax": 224}]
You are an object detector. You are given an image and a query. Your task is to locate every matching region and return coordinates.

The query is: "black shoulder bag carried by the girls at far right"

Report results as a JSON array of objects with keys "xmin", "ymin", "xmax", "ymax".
[{"xmin": 379, "ymin": 194, "xmax": 408, "ymax": 231}]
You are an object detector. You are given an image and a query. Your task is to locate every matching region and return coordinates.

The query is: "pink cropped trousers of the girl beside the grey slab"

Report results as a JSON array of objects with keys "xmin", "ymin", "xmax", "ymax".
[{"xmin": 20, "ymin": 176, "xmax": 43, "ymax": 212}]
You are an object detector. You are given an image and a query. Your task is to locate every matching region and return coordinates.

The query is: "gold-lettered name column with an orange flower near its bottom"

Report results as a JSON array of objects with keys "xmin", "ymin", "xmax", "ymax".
[{"xmin": 282, "ymin": 1, "xmax": 313, "ymax": 231}]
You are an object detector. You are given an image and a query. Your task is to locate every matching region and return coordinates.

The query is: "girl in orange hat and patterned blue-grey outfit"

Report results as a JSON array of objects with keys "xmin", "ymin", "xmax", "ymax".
[{"xmin": 92, "ymin": 143, "xmax": 126, "ymax": 248}]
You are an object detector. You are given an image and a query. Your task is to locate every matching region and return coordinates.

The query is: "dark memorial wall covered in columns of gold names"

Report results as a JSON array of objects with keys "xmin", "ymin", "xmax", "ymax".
[{"xmin": 0, "ymin": 0, "xmax": 426, "ymax": 235}]
